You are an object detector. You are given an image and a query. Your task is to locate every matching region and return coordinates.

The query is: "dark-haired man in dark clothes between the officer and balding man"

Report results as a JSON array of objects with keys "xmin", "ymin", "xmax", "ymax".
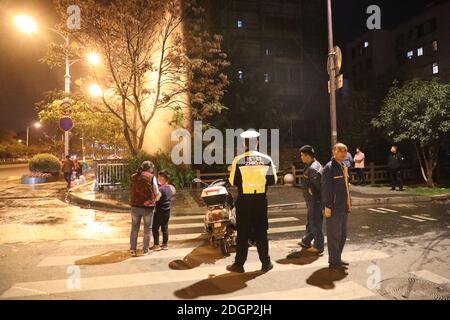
[{"xmin": 300, "ymin": 145, "xmax": 324, "ymax": 254}]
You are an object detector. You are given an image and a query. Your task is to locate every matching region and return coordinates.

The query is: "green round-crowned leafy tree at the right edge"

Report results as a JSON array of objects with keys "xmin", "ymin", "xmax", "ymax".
[{"xmin": 372, "ymin": 79, "xmax": 450, "ymax": 187}]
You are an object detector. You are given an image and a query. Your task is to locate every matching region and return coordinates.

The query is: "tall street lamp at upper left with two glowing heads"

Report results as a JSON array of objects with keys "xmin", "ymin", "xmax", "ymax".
[{"xmin": 14, "ymin": 15, "xmax": 100, "ymax": 155}]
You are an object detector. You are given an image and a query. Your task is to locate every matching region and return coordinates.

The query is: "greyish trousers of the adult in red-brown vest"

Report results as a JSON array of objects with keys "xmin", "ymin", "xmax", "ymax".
[{"xmin": 130, "ymin": 207, "xmax": 154, "ymax": 252}]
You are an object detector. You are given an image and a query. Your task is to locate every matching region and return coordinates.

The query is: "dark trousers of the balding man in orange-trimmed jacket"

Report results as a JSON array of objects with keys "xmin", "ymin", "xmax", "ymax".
[{"xmin": 326, "ymin": 212, "xmax": 348, "ymax": 266}]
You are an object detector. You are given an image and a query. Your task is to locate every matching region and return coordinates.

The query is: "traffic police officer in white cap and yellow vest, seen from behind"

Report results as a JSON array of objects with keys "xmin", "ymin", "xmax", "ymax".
[{"xmin": 227, "ymin": 130, "xmax": 277, "ymax": 273}]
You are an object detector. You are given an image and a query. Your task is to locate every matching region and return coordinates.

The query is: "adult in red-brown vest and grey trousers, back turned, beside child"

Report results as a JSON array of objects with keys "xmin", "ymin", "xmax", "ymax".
[{"xmin": 130, "ymin": 161, "xmax": 159, "ymax": 257}]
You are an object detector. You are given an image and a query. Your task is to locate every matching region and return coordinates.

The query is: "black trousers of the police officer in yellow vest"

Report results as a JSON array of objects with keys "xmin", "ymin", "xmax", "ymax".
[{"xmin": 235, "ymin": 194, "xmax": 270, "ymax": 265}]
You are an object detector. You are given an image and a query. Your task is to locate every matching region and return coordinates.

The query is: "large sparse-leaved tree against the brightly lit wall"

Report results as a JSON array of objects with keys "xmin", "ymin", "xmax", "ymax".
[{"xmin": 45, "ymin": 0, "xmax": 227, "ymax": 155}]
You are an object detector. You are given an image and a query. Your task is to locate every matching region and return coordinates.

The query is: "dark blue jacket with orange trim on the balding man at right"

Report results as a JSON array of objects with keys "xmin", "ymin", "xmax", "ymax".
[{"xmin": 322, "ymin": 158, "xmax": 351, "ymax": 214}]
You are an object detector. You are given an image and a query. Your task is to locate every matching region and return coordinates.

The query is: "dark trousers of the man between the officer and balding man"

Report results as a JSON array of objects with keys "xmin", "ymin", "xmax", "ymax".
[{"xmin": 302, "ymin": 200, "xmax": 324, "ymax": 250}]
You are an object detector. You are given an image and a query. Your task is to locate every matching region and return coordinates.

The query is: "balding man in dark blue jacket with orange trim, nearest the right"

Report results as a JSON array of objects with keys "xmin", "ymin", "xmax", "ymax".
[{"xmin": 322, "ymin": 143, "xmax": 351, "ymax": 272}]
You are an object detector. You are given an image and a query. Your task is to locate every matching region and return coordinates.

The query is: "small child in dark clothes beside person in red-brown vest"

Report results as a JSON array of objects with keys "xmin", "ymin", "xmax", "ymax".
[{"xmin": 151, "ymin": 170, "xmax": 173, "ymax": 251}]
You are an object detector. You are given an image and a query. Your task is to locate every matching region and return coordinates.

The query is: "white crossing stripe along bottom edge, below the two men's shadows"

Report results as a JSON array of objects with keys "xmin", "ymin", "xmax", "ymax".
[{"xmin": 225, "ymin": 281, "xmax": 375, "ymax": 300}]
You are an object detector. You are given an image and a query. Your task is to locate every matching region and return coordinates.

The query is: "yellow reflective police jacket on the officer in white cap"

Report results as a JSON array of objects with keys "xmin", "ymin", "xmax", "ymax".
[{"xmin": 229, "ymin": 151, "xmax": 277, "ymax": 195}]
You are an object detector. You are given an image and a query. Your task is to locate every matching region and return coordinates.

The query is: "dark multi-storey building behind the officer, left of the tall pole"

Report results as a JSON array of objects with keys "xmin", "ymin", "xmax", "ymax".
[{"xmin": 211, "ymin": 0, "xmax": 328, "ymax": 146}]
